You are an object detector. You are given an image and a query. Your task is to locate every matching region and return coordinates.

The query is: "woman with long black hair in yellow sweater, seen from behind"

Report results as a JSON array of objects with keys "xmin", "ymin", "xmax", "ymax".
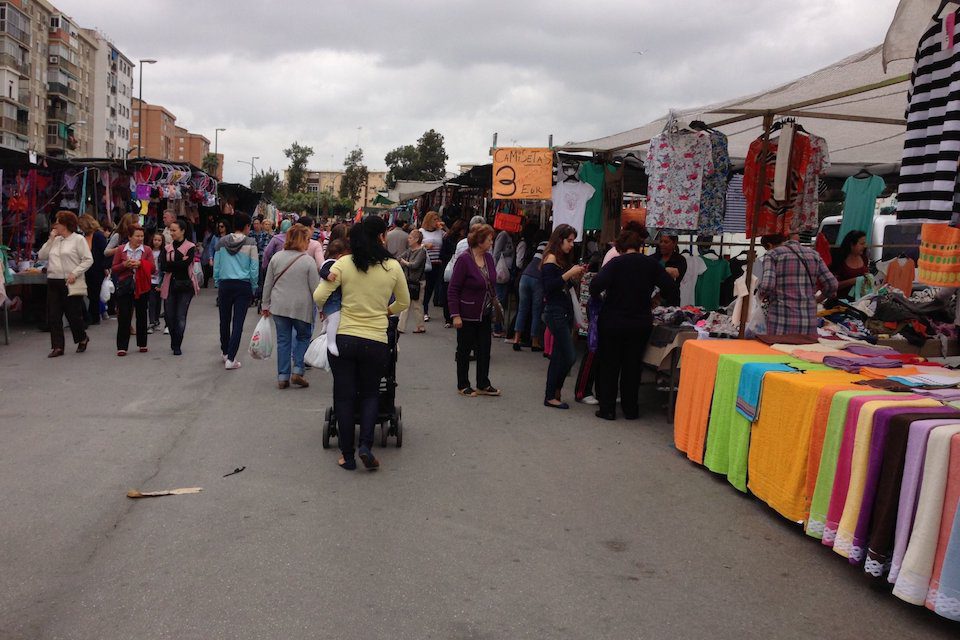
[{"xmin": 313, "ymin": 216, "xmax": 410, "ymax": 471}]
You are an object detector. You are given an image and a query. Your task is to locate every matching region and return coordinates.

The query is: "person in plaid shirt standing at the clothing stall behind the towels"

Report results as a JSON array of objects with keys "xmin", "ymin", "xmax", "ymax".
[{"xmin": 757, "ymin": 234, "xmax": 837, "ymax": 335}]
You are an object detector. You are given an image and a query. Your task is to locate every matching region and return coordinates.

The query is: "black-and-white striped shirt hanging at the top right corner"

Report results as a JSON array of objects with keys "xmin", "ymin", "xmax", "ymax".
[{"xmin": 897, "ymin": 13, "xmax": 960, "ymax": 220}]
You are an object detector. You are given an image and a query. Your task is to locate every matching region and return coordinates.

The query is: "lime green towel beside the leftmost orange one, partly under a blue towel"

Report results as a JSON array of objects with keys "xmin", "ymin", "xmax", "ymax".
[{"xmin": 703, "ymin": 354, "xmax": 829, "ymax": 493}]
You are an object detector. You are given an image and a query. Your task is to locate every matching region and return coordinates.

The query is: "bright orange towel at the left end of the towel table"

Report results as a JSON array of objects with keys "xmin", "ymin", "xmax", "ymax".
[{"xmin": 673, "ymin": 340, "xmax": 778, "ymax": 464}]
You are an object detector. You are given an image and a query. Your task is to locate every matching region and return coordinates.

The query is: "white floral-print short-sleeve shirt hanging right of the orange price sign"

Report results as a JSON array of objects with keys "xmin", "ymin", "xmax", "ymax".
[{"xmin": 646, "ymin": 131, "xmax": 713, "ymax": 231}]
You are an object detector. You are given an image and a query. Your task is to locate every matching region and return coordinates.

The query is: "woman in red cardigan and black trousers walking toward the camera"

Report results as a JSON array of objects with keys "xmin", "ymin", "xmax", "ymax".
[{"xmin": 112, "ymin": 226, "xmax": 157, "ymax": 356}]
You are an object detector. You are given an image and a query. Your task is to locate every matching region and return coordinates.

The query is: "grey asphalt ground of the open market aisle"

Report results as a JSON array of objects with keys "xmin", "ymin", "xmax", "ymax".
[{"xmin": 0, "ymin": 292, "xmax": 960, "ymax": 640}]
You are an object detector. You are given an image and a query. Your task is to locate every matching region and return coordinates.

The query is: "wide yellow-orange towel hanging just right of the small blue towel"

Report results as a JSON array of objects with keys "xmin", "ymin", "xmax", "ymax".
[{"xmin": 747, "ymin": 371, "xmax": 860, "ymax": 522}]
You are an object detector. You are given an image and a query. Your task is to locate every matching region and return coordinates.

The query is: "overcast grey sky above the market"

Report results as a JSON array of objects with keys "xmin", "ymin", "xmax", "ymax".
[{"xmin": 53, "ymin": 0, "xmax": 897, "ymax": 183}]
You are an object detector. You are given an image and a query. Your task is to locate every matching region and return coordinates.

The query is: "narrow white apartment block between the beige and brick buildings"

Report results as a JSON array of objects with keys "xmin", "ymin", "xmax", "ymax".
[{"xmin": 82, "ymin": 29, "xmax": 133, "ymax": 158}]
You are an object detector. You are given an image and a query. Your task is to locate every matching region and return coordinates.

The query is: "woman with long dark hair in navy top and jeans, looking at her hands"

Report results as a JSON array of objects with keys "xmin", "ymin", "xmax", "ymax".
[{"xmin": 540, "ymin": 224, "xmax": 586, "ymax": 409}]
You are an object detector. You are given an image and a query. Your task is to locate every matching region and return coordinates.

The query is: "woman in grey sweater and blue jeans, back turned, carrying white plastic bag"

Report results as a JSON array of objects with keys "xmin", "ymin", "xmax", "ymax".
[{"xmin": 261, "ymin": 224, "xmax": 320, "ymax": 389}]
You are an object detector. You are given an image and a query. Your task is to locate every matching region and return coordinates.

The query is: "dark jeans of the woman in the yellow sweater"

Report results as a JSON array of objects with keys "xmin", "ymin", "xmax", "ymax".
[{"xmin": 329, "ymin": 334, "xmax": 390, "ymax": 459}]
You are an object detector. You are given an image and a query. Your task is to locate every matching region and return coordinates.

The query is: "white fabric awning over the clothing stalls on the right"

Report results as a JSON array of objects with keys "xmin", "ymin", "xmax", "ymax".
[{"xmin": 560, "ymin": 42, "xmax": 916, "ymax": 175}]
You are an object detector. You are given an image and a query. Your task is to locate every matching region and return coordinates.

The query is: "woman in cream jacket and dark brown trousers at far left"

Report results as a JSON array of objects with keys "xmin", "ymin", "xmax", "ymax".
[{"xmin": 38, "ymin": 211, "xmax": 93, "ymax": 358}]
